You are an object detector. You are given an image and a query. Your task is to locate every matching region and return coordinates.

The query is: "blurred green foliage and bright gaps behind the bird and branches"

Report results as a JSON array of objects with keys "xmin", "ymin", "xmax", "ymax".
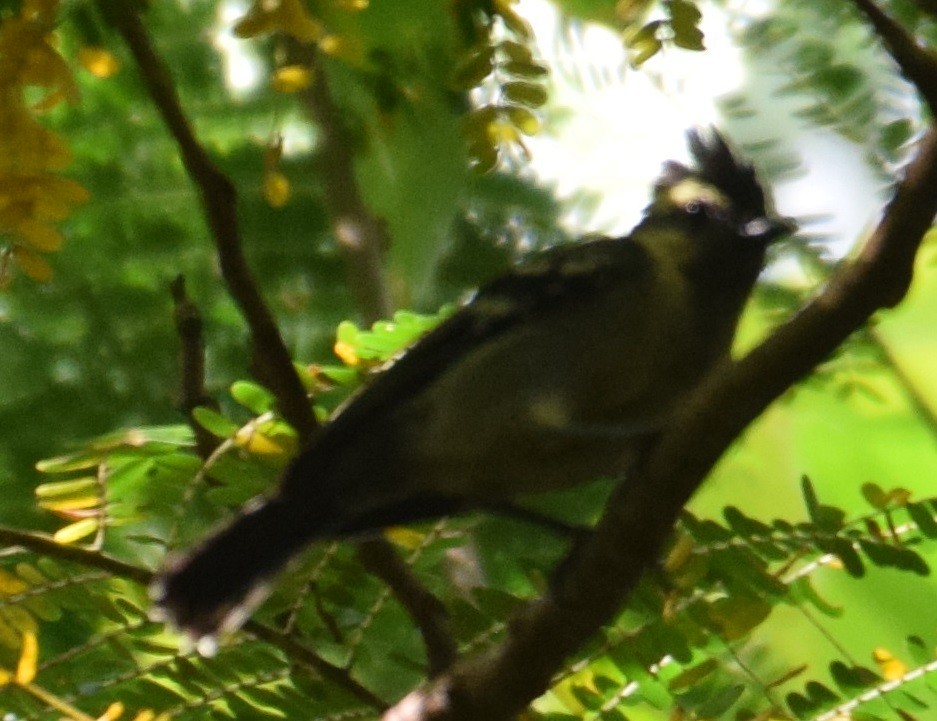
[{"xmin": 0, "ymin": 0, "xmax": 937, "ymax": 721}]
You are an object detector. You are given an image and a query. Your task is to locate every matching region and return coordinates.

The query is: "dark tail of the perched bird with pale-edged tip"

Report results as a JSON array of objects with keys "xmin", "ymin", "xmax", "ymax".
[{"xmin": 151, "ymin": 496, "xmax": 318, "ymax": 652}]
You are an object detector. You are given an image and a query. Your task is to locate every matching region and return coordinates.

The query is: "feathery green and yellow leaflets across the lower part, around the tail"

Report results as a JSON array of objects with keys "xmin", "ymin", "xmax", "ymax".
[{"xmin": 0, "ymin": 312, "xmax": 937, "ymax": 721}]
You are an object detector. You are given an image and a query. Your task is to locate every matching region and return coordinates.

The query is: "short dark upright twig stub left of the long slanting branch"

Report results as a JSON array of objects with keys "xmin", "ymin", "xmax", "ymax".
[{"xmin": 169, "ymin": 275, "xmax": 220, "ymax": 460}]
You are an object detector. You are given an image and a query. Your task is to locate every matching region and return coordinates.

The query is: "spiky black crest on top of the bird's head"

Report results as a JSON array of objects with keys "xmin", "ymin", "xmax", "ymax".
[{"xmin": 658, "ymin": 128, "xmax": 768, "ymax": 220}]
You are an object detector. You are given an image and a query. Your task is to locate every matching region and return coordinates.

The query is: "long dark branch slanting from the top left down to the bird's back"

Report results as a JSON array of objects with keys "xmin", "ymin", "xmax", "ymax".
[{"xmin": 99, "ymin": 0, "xmax": 317, "ymax": 438}]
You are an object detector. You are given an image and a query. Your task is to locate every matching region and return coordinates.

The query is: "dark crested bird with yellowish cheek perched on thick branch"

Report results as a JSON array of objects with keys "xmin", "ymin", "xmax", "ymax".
[{"xmin": 153, "ymin": 131, "xmax": 792, "ymax": 640}]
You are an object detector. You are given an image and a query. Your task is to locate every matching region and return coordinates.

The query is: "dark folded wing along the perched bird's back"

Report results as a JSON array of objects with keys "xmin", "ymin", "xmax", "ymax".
[{"xmin": 320, "ymin": 238, "xmax": 651, "ymax": 441}]
